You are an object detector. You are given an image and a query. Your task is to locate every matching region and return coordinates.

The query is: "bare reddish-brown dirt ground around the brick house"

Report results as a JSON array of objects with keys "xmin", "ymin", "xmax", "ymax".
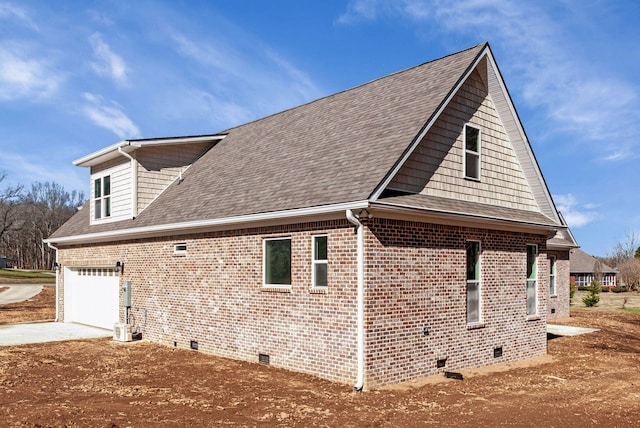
[{"xmin": 0, "ymin": 288, "xmax": 640, "ymax": 428}]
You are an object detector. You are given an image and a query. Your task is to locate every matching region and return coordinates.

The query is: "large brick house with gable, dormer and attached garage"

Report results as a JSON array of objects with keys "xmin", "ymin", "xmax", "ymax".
[{"xmin": 46, "ymin": 44, "xmax": 575, "ymax": 390}]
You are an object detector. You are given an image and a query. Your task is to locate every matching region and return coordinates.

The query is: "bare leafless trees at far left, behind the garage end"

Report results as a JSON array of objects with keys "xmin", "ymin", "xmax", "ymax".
[{"xmin": 0, "ymin": 172, "xmax": 85, "ymax": 269}]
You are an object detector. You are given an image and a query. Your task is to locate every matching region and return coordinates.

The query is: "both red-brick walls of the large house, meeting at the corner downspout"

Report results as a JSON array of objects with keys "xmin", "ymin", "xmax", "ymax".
[{"xmin": 58, "ymin": 219, "xmax": 548, "ymax": 389}]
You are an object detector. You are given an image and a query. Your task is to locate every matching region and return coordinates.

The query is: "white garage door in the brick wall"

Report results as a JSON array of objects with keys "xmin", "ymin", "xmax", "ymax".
[{"xmin": 64, "ymin": 268, "xmax": 120, "ymax": 329}]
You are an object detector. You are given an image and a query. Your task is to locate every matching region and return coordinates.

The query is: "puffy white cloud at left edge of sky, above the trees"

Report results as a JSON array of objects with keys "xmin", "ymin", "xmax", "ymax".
[{"xmin": 0, "ymin": 43, "xmax": 63, "ymax": 101}]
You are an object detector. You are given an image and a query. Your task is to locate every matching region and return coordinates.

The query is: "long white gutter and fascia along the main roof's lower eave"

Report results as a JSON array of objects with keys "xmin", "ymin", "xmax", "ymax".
[{"xmin": 44, "ymin": 200, "xmax": 369, "ymax": 245}]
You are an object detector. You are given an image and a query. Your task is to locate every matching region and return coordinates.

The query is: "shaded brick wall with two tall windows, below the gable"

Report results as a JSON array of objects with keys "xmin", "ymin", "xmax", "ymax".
[{"xmin": 365, "ymin": 219, "xmax": 548, "ymax": 387}]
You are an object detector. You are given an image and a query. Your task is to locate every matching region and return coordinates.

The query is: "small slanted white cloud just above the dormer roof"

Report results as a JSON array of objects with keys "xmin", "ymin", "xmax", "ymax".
[{"xmin": 82, "ymin": 92, "xmax": 140, "ymax": 139}]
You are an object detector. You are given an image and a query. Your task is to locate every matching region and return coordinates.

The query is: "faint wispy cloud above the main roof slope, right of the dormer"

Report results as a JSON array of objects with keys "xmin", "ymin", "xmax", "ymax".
[{"xmin": 168, "ymin": 27, "xmax": 321, "ymax": 126}]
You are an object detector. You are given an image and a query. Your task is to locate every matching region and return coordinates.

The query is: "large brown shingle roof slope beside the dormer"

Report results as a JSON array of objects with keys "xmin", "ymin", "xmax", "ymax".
[{"xmin": 49, "ymin": 44, "xmax": 487, "ymax": 239}]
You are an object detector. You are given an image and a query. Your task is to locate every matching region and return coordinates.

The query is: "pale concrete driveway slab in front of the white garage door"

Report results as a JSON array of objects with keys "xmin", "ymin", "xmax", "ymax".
[{"xmin": 0, "ymin": 322, "xmax": 113, "ymax": 346}]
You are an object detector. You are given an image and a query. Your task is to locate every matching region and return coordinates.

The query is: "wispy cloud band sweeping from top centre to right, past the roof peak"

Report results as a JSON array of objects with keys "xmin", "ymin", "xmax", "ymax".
[{"xmin": 337, "ymin": 0, "xmax": 640, "ymax": 160}]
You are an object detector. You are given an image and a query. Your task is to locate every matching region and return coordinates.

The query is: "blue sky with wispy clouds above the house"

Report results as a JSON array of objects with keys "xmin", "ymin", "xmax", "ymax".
[{"xmin": 0, "ymin": 0, "xmax": 640, "ymax": 255}]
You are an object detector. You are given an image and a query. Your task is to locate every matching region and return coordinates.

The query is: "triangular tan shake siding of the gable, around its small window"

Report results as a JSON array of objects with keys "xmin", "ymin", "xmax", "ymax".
[{"xmin": 389, "ymin": 70, "xmax": 539, "ymax": 211}]
